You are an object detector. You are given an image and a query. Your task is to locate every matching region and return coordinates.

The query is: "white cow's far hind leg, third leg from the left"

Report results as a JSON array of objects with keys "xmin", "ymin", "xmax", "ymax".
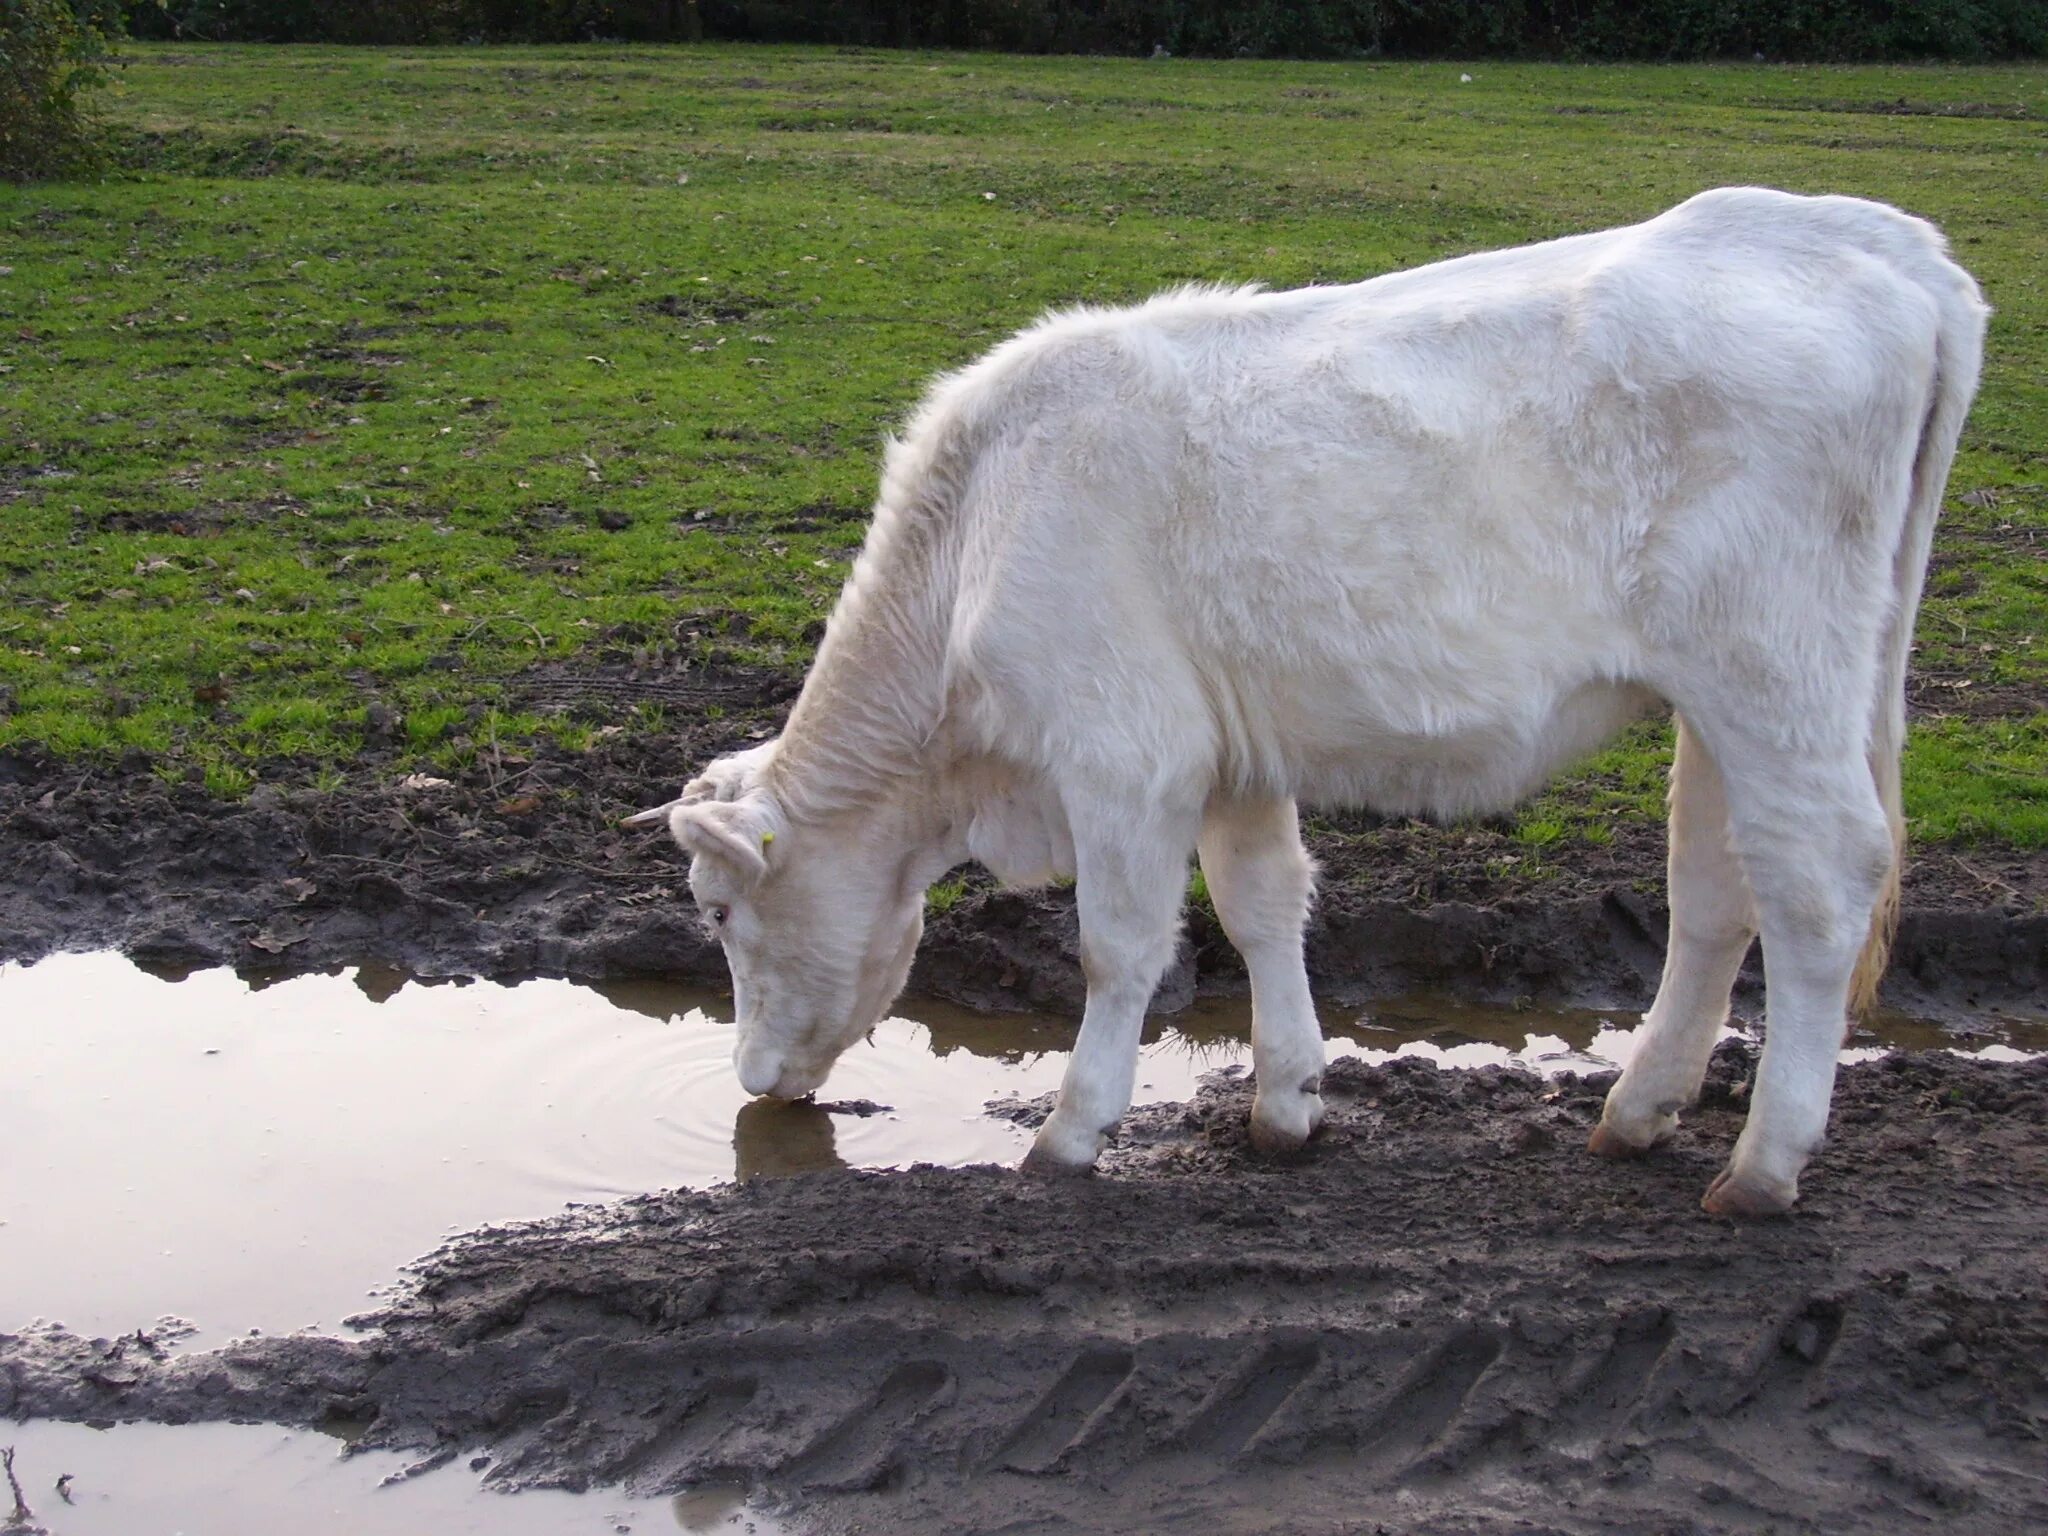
[{"xmin": 1587, "ymin": 717, "xmax": 1757, "ymax": 1157}]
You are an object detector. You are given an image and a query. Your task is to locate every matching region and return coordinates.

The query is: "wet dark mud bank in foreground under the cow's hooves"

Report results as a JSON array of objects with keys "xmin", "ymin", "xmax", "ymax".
[{"xmin": 0, "ymin": 1042, "xmax": 2048, "ymax": 1532}]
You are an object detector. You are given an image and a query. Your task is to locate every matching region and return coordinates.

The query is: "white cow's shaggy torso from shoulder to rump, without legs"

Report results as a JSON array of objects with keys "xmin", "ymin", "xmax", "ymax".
[{"xmin": 937, "ymin": 188, "xmax": 1974, "ymax": 811}]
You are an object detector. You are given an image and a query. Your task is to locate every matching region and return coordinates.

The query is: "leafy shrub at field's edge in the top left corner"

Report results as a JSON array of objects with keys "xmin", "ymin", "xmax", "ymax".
[{"xmin": 0, "ymin": 0, "xmax": 121, "ymax": 182}]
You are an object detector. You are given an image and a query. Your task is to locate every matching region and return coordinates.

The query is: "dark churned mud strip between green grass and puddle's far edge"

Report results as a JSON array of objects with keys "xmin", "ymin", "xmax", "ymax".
[{"xmin": 0, "ymin": 667, "xmax": 2048, "ymax": 1016}]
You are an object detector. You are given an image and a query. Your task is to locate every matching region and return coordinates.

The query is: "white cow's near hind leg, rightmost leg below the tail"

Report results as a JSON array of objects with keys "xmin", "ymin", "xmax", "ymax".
[{"xmin": 1694, "ymin": 711, "xmax": 1894, "ymax": 1217}]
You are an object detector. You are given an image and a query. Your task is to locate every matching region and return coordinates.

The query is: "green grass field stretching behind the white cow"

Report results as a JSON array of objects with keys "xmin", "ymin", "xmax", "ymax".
[{"xmin": 0, "ymin": 45, "xmax": 2048, "ymax": 850}]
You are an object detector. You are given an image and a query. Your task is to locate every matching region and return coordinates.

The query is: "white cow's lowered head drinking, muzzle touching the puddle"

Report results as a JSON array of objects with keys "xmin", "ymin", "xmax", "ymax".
[{"xmin": 638, "ymin": 741, "xmax": 942, "ymax": 1098}]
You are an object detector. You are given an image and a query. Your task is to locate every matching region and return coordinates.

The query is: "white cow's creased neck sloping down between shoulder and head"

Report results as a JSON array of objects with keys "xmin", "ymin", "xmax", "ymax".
[{"xmin": 772, "ymin": 475, "xmax": 956, "ymax": 819}]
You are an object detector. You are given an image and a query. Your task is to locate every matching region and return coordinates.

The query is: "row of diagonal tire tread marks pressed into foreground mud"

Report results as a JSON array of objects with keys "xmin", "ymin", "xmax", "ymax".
[{"xmin": 432, "ymin": 1300, "xmax": 2048, "ymax": 1530}]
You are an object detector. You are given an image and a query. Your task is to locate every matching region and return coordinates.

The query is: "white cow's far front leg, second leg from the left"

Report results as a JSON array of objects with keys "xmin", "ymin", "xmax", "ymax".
[{"xmin": 1200, "ymin": 797, "xmax": 1323, "ymax": 1153}]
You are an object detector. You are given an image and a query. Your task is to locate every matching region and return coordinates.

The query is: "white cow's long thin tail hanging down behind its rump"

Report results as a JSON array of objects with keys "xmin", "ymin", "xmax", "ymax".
[{"xmin": 1849, "ymin": 258, "xmax": 1991, "ymax": 1018}]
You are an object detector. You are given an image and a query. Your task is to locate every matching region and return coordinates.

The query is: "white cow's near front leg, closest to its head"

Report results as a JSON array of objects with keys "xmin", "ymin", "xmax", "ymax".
[{"xmin": 1024, "ymin": 799, "xmax": 1198, "ymax": 1174}]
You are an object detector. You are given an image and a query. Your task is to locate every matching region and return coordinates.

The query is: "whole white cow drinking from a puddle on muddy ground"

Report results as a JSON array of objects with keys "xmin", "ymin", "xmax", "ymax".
[{"xmin": 633, "ymin": 188, "xmax": 1987, "ymax": 1214}]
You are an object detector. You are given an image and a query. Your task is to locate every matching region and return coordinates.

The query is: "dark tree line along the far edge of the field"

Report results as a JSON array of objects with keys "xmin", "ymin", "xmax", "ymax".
[{"xmin": 127, "ymin": 0, "xmax": 2048, "ymax": 59}]
